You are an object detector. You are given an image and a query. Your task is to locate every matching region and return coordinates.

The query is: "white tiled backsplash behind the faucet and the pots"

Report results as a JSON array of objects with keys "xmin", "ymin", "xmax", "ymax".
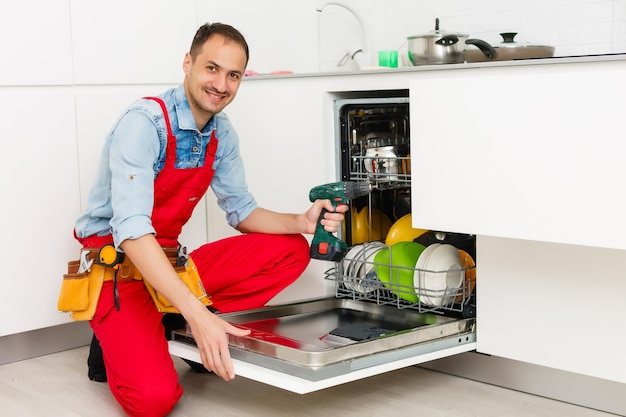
[{"xmin": 318, "ymin": 0, "xmax": 626, "ymax": 71}]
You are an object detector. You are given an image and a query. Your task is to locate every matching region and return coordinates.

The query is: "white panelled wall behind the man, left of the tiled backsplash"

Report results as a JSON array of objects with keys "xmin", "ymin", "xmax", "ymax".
[{"xmin": 0, "ymin": 0, "xmax": 318, "ymax": 337}]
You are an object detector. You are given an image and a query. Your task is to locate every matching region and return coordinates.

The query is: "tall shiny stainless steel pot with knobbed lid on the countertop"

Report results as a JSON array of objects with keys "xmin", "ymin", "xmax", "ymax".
[{"xmin": 407, "ymin": 18, "xmax": 468, "ymax": 65}]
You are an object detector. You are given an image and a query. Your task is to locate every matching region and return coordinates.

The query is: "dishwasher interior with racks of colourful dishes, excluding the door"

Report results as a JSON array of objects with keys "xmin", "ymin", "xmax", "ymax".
[{"xmin": 326, "ymin": 97, "xmax": 476, "ymax": 318}]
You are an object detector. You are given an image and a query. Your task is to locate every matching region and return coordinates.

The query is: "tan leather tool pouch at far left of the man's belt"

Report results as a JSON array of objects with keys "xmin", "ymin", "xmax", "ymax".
[{"xmin": 57, "ymin": 260, "xmax": 114, "ymax": 321}]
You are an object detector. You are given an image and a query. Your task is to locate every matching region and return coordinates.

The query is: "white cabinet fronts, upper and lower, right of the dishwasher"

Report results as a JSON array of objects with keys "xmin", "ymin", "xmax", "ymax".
[{"xmin": 411, "ymin": 60, "xmax": 626, "ymax": 383}]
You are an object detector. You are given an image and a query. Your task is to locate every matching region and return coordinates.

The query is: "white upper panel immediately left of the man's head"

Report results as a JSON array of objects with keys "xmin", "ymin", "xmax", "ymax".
[{"xmin": 70, "ymin": 0, "xmax": 197, "ymax": 84}]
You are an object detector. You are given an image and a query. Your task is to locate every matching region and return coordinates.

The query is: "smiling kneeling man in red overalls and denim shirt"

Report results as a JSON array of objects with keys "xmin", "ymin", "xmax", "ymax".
[{"xmin": 75, "ymin": 23, "xmax": 347, "ymax": 416}]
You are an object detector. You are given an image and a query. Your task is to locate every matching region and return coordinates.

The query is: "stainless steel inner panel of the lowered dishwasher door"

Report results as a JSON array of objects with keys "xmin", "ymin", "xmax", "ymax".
[{"xmin": 174, "ymin": 298, "xmax": 475, "ymax": 368}]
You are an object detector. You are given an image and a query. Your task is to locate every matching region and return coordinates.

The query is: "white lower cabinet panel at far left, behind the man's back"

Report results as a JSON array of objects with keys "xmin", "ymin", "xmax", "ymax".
[{"xmin": 0, "ymin": 90, "xmax": 80, "ymax": 336}]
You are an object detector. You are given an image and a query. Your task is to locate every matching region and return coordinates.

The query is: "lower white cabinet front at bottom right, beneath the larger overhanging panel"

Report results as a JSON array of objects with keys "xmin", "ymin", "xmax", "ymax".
[{"xmin": 476, "ymin": 236, "xmax": 626, "ymax": 384}]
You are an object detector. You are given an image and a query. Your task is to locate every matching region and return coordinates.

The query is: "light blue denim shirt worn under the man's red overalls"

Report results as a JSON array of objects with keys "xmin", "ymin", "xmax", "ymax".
[{"xmin": 75, "ymin": 85, "xmax": 258, "ymax": 247}]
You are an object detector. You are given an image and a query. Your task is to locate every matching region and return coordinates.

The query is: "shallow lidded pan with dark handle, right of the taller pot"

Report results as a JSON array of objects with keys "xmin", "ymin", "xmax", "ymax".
[{"xmin": 464, "ymin": 32, "xmax": 554, "ymax": 62}]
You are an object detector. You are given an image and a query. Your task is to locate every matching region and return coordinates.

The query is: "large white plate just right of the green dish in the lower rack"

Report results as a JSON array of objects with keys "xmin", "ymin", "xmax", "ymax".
[{"xmin": 419, "ymin": 244, "xmax": 465, "ymax": 307}]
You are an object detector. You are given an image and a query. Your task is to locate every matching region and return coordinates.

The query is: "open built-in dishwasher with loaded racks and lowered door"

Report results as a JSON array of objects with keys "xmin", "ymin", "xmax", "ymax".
[{"xmin": 169, "ymin": 92, "xmax": 476, "ymax": 394}]
